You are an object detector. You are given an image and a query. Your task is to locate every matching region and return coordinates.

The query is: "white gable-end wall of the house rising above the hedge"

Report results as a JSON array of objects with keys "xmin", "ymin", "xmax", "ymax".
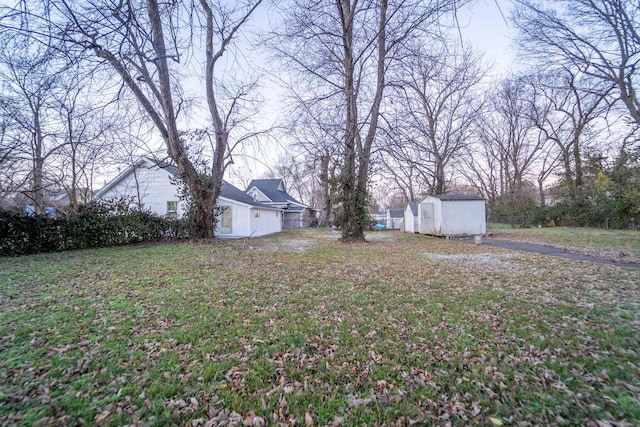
[{"xmin": 100, "ymin": 167, "xmax": 185, "ymax": 217}]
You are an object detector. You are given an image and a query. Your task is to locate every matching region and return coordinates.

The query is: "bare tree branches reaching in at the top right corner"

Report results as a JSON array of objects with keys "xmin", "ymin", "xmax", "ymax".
[{"xmin": 513, "ymin": 0, "xmax": 640, "ymax": 123}]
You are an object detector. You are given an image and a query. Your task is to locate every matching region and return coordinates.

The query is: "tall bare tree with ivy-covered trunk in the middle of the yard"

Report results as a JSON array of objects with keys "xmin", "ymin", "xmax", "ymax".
[{"xmin": 273, "ymin": 0, "xmax": 465, "ymax": 242}]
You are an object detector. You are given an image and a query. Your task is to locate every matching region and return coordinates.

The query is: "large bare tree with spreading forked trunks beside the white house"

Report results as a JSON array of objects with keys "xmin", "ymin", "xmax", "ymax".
[{"xmin": 0, "ymin": 0, "xmax": 262, "ymax": 237}]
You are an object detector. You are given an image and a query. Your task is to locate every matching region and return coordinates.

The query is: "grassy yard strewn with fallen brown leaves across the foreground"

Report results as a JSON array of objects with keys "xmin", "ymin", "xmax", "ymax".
[{"xmin": 0, "ymin": 229, "xmax": 640, "ymax": 426}]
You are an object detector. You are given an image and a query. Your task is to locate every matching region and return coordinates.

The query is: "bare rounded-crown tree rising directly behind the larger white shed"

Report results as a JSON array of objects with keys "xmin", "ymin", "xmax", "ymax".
[{"xmin": 390, "ymin": 44, "xmax": 485, "ymax": 194}]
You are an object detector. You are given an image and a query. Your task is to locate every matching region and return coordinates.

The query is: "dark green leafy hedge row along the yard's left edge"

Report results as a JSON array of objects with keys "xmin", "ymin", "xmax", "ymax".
[{"xmin": 0, "ymin": 202, "xmax": 186, "ymax": 256}]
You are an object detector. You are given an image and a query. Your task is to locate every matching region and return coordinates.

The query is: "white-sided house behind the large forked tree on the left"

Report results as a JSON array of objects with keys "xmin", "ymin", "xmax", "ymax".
[{"xmin": 95, "ymin": 157, "xmax": 282, "ymax": 237}]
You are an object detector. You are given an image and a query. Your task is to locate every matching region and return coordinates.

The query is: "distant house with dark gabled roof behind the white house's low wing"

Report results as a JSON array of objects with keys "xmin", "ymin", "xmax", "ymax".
[{"xmin": 247, "ymin": 178, "xmax": 318, "ymax": 228}]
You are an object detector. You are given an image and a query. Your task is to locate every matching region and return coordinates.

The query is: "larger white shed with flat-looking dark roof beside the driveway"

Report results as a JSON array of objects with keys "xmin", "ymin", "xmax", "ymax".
[{"xmin": 418, "ymin": 194, "xmax": 487, "ymax": 237}]
